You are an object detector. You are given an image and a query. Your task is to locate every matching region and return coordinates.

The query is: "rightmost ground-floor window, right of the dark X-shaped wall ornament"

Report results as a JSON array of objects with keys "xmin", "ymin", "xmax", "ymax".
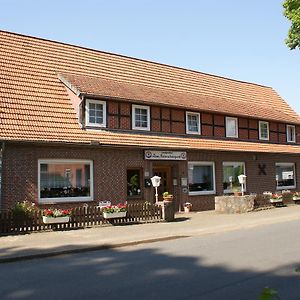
[{"xmin": 276, "ymin": 163, "xmax": 296, "ymax": 190}]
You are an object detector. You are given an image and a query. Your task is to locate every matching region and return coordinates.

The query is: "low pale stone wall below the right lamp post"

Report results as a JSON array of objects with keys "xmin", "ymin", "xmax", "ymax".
[{"xmin": 215, "ymin": 195, "xmax": 255, "ymax": 214}]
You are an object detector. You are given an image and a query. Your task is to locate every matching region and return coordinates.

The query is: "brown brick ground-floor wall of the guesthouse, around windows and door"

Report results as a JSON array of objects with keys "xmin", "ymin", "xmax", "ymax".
[{"xmin": 1, "ymin": 143, "xmax": 300, "ymax": 211}]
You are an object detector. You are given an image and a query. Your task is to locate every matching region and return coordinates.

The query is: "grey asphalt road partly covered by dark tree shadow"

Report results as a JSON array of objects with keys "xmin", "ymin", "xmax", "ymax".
[{"xmin": 0, "ymin": 222, "xmax": 300, "ymax": 300}]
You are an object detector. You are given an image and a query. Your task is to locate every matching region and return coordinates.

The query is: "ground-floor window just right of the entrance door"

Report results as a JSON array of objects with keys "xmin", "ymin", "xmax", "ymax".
[{"xmin": 188, "ymin": 162, "xmax": 216, "ymax": 195}]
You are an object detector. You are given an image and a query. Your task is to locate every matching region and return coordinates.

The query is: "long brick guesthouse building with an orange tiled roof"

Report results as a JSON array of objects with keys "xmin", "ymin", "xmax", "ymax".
[{"xmin": 0, "ymin": 31, "xmax": 300, "ymax": 210}]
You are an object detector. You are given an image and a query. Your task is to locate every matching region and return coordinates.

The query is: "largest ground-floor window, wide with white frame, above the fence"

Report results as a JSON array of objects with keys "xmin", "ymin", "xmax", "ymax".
[{"xmin": 38, "ymin": 159, "xmax": 93, "ymax": 203}]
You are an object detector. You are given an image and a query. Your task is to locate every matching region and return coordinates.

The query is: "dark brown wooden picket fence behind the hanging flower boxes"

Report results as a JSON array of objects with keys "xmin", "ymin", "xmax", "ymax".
[{"xmin": 0, "ymin": 203, "xmax": 163, "ymax": 235}]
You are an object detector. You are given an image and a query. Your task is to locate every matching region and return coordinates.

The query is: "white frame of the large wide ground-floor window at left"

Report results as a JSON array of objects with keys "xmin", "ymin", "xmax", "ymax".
[{"xmin": 38, "ymin": 159, "xmax": 94, "ymax": 204}]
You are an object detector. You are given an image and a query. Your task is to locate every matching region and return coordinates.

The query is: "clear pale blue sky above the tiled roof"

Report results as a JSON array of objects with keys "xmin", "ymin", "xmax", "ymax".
[{"xmin": 0, "ymin": 0, "xmax": 300, "ymax": 113}]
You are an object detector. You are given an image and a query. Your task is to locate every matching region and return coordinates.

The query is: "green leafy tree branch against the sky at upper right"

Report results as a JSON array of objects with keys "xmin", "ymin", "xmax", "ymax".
[{"xmin": 283, "ymin": 0, "xmax": 300, "ymax": 50}]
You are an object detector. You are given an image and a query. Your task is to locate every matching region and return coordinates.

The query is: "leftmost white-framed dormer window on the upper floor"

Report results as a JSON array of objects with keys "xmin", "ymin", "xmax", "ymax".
[{"xmin": 85, "ymin": 99, "xmax": 106, "ymax": 127}]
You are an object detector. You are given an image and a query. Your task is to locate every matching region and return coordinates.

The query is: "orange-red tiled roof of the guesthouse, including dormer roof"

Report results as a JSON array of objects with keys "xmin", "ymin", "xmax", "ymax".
[{"xmin": 0, "ymin": 31, "xmax": 300, "ymax": 153}]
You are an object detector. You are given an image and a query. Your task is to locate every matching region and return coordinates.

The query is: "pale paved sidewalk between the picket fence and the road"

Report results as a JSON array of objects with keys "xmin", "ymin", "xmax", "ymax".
[{"xmin": 0, "ymin": 205, "xmax": 300, "ymax": 263}]
